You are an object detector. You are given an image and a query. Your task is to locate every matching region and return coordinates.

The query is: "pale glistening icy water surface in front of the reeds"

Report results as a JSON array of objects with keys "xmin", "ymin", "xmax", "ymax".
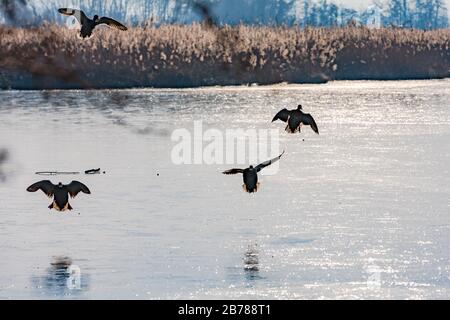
[{"xmin": 0, "ymin": 80, "xmax": 450, "ymax": 299}]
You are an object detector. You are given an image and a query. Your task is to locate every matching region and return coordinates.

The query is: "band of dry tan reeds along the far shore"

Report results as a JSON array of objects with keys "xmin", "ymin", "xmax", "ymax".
[{"xmin": 0, "ymin": 24, "xmax": 450, "ymax": 89}]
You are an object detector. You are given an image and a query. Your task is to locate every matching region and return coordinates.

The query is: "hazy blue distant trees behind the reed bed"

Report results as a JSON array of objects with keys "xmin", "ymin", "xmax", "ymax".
[{"xmin": 0, "ymin": 0, "xmax": 449, "ymax": 30}]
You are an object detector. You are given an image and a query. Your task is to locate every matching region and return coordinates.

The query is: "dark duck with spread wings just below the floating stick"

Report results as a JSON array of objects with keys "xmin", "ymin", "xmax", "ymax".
[{"xmin": 27, "ymin": 180, "xmax": 91, "ymax": 212}]
